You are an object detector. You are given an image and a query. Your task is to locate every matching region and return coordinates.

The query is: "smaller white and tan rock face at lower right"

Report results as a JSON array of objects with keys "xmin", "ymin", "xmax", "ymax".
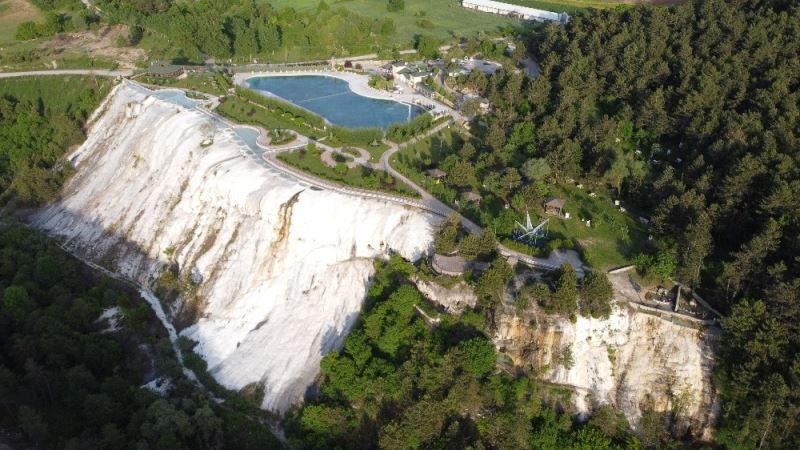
[{"xmin": 495, "ymin": 305, "xmax": 717, "ymax": 438}]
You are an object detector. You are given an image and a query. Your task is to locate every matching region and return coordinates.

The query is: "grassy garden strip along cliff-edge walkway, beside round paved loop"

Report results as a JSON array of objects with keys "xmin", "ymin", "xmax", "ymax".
[{"xmin": 278, "ymin": 148, "xmax": 419, "ymax": 197}]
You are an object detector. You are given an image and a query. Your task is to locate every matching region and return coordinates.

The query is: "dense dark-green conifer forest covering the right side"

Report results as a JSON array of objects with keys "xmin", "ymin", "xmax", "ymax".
[{"xmin": 456, "ymin": 0, "xmax": 800, "ymax": 448}]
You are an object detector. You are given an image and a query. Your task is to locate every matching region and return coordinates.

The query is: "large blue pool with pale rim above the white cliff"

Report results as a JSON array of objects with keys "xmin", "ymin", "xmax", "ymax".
[{"xmin": 247, "ymin": 75, "xmax": 424, "ymax": 129}]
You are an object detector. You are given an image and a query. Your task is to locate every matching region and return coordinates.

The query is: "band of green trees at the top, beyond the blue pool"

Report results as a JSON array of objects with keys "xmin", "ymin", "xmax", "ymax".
[{"xmin": 96, "ymin": 0, "xmax": 395, "ymax": 63}]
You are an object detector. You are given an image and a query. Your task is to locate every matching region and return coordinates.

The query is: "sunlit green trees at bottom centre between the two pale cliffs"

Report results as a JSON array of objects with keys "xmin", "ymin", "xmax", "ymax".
[{"xmin": 287, "ymin": 256, "xmax": 636, "ymax": 450}]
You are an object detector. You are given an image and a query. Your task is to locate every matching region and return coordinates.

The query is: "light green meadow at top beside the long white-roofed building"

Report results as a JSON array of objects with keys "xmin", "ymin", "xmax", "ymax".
[{"xmin": 260, "ymin": 0, "xmax": 519, "ymax": 47}]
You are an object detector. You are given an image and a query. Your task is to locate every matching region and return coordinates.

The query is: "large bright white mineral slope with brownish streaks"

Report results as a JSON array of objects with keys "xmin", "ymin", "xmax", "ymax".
[{"xmin": 31, "ymin": 84, "xmax": 437, "ymax": 411}]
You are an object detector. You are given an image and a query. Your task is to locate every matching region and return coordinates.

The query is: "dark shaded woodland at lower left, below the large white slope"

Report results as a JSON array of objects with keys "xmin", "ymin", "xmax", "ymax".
[{"xmin": 0, "ymin": 224, "xmax": 278, "ymax": 449}]
